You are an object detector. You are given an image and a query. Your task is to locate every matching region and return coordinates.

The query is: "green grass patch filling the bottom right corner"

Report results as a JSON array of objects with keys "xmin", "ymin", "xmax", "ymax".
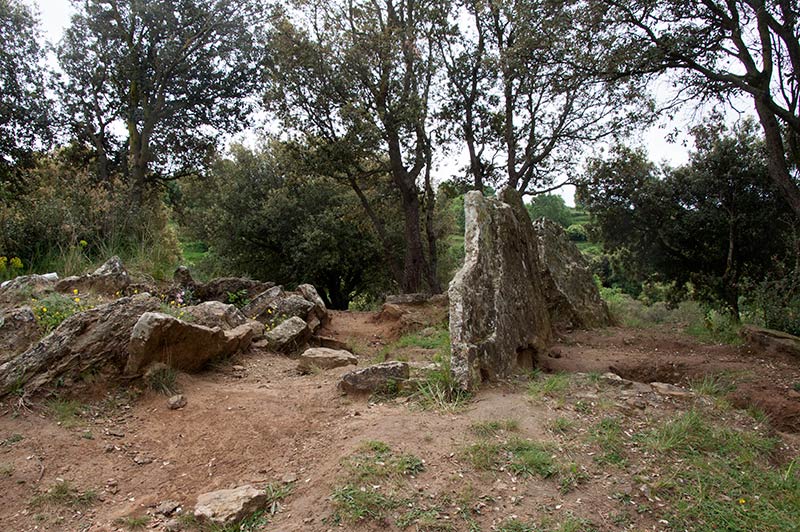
[{"xmin": 640, "ymin": 411, "xmax": 800, "ymax": 532}]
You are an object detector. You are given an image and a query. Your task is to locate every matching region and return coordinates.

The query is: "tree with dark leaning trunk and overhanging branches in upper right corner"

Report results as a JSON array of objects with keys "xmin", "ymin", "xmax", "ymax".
[{"xmin": 586, "ymin": 0, "xmax": 800, "ymax": 217}]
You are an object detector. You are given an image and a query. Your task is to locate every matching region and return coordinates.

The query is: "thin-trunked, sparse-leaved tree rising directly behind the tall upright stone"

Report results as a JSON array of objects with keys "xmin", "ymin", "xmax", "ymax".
[{"xmin": 439, "ymin": 0, "xmax": 649, "ymax": 194}]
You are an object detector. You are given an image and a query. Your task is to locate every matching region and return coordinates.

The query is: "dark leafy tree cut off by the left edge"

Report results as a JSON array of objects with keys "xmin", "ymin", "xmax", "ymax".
[{"xmin": 0, "ymin": 0, "xmax": 50, "ymax": 191}]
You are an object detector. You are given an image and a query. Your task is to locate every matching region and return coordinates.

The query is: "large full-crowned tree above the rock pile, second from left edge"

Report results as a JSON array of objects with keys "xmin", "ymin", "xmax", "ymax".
[{"xmin": 58, "ymin": 0, "xmax": 266, "ymax": 204}]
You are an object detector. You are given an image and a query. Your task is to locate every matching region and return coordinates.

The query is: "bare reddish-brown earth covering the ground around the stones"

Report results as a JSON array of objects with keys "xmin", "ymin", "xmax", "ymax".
[{"xmin": 0, "ymin": 310, "xmax": 800, "ymax": 531}]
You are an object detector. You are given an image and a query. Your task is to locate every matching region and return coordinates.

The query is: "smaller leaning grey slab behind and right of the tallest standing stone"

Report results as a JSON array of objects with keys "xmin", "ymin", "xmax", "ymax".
[{"xmin": 533, "ymin": 218, "xmax": 611, "ymax": 329}]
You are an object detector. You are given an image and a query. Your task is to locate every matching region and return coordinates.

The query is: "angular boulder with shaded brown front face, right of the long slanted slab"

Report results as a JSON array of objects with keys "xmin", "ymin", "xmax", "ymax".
[{"xmin": 125, "ymin": 312, "xmax": 255, "ymax": 375}]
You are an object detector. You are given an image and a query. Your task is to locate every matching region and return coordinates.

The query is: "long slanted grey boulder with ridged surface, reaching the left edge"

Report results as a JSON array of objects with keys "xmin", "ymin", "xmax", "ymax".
[{"xmin": 0, "ymin": 294, "xmax": 160, "ymax": 396}]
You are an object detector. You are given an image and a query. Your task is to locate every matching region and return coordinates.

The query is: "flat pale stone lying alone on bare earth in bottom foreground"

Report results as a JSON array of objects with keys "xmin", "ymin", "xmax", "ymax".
[{"xmin": 194, "ymin": 484, "xmax": 269, "ymax": 528}]
